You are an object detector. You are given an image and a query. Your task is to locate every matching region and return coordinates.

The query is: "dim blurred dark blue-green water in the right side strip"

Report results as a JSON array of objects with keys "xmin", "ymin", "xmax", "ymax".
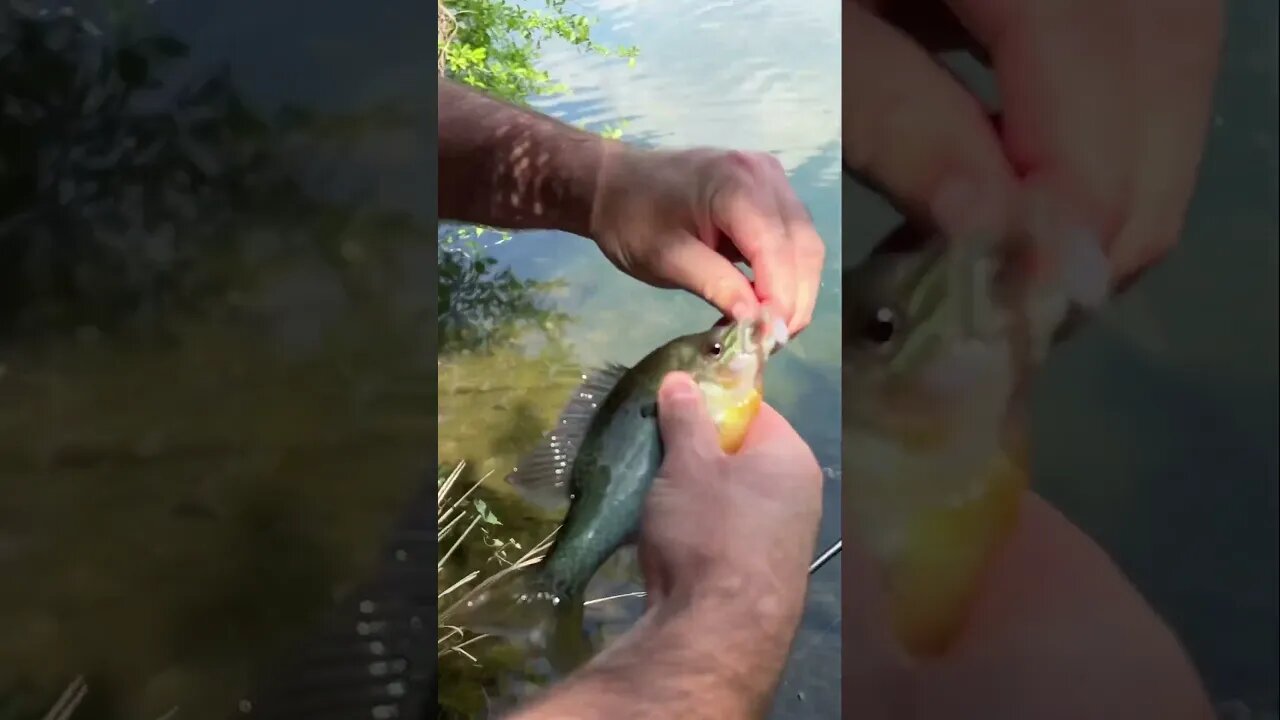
[{"xmin": 844, "ymin": 3, "xmax": 1280, "ymax": 717}]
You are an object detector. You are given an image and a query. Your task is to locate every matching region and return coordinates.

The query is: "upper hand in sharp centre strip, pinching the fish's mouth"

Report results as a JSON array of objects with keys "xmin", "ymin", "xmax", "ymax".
[{"xmin": 590, "ymin": 143, "xmax": 826, "ymax": 336}]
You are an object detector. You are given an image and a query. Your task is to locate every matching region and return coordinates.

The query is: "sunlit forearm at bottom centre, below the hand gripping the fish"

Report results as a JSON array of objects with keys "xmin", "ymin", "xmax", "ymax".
[{"xmin": 511, "ymin": 579, "xmax": 803, "ymax": 720}]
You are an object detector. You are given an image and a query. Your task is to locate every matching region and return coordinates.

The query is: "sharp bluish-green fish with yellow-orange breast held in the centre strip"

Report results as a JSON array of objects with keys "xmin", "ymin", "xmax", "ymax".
[{"xmin": 507, "ymin": 307, "xmax": 788, "ymax": 666}]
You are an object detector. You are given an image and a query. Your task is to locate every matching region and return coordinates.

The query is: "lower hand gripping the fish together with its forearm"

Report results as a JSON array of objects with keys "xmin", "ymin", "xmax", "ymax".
[{"xmin": 517, "ymin": 373, "xmax": 822, "ymax": 720}]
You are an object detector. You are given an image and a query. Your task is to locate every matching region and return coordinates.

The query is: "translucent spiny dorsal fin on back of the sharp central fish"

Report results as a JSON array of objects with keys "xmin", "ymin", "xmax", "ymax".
[{"xmin": 507, "ymin": 363, "xmax": 630, "ymax": 506}]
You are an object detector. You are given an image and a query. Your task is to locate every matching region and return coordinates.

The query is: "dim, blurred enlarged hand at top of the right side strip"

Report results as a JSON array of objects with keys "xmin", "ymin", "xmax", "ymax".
[{"xmin": 844, "ymin": 0, "xmax": 1221, "ymax": 286}]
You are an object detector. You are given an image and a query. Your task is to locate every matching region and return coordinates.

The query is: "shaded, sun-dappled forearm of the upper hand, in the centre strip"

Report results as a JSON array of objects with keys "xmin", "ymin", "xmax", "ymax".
[{"xmin": 439, "ymin": 78, "xmax": 623, "ymax": 237}]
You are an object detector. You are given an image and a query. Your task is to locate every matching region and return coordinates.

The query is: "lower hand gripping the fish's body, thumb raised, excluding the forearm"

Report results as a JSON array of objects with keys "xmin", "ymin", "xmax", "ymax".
[{"xmin": 640, "ymin": 373, "xmax": 822, "ymax": 621}]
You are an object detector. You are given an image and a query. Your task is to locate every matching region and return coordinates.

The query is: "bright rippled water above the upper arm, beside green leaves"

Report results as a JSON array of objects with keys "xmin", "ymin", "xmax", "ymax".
[{"xmin": 529, "ymin": 1, "xmax": 840, "ymax": 182}]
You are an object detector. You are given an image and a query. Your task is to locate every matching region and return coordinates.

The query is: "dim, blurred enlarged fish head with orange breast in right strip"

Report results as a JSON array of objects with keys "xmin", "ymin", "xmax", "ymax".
[{"xmin": 841, "ymin": 223, "xmax": 1108, "ymax": 657}]
